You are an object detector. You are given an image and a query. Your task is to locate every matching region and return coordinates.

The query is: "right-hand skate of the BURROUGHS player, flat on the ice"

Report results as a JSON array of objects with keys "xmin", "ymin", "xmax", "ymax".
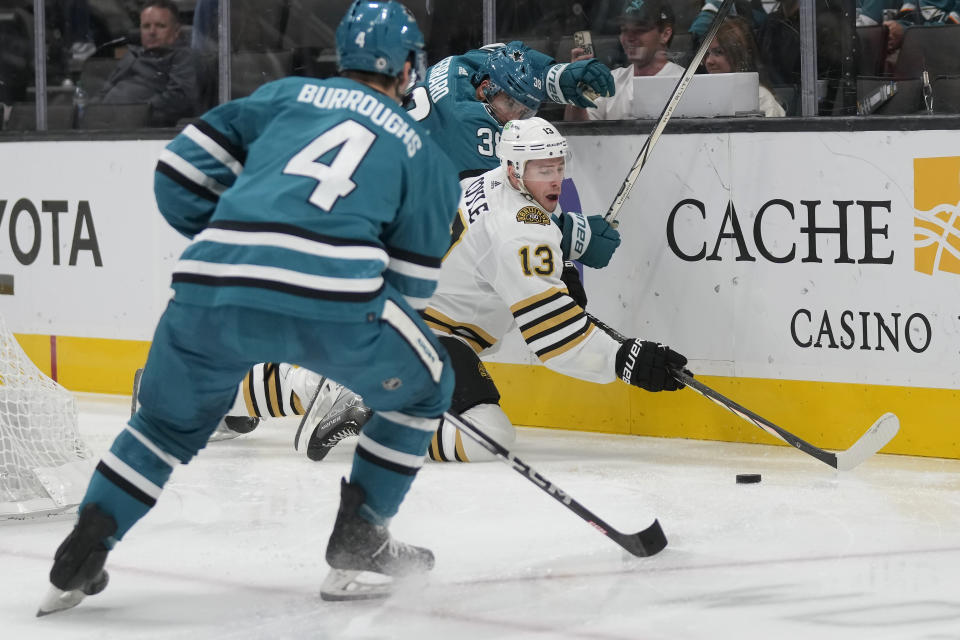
[{"xmin": 320, "ymin": 480, "xmax": 433, "ymax": 600}]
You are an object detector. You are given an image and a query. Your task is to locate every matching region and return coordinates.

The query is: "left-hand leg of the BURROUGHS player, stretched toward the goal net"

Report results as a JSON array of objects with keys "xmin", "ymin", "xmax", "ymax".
[{"xmin": 38, "ymin": 301, "xmax": 248, "ymax": 615}]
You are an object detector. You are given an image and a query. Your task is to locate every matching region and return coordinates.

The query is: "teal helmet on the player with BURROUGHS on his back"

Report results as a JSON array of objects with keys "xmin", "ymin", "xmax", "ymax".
[{"xmin": 337, "ymin": 0, "xmax": 427, "ymax": 88}]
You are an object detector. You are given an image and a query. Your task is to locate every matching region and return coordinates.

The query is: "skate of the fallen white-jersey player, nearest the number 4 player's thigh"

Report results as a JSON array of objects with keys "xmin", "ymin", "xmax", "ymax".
[{"xmin": 293, "ymin": 378, "xmax": 373, "ymax": 462}]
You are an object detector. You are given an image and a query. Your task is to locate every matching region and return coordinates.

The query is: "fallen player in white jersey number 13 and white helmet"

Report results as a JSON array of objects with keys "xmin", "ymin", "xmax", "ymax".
[{"xmin": 274, "ymin": 118, "xmax": 687, "ymax": 462}]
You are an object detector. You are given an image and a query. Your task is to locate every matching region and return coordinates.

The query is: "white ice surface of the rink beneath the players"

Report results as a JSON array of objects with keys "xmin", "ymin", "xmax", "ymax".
[{"xmin": 0, "ymin": 395, "xmax": 960, "ymax": 640}]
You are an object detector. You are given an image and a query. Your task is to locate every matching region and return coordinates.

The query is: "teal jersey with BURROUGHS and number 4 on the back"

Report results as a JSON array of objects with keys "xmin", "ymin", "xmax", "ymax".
[{"xmin": 154, "ymin": 77, "xmax": 460, "ymax": 322}]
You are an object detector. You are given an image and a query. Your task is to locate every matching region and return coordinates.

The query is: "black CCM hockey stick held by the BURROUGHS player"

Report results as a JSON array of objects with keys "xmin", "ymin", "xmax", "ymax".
[{"xmin": 443, "ymin": 412, "xmax": 667, "ymax": 558}]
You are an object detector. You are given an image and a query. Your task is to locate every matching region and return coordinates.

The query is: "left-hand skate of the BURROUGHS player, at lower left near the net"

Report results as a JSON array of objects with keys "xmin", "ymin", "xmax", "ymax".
[{"xmin": 37, "ymin": 504, "xmax": 117, "ymax": 617}]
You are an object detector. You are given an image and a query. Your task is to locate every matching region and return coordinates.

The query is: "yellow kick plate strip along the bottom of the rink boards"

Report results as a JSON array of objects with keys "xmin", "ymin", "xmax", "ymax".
[{"xmin": 9, "ymin": 335, "xmax": 960, "ymax": 458}]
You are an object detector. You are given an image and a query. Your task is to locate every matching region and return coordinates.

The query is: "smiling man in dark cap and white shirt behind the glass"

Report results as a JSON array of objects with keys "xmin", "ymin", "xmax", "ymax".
[{"xmin": 564, "ymin": 0, "xmax": 684, "ymax": 120}]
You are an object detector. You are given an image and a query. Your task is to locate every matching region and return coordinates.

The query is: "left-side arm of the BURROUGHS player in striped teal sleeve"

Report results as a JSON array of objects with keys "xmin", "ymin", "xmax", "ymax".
[{"xmin": 153, "ymin": 85, "xmax": 275, "ymax": 239}]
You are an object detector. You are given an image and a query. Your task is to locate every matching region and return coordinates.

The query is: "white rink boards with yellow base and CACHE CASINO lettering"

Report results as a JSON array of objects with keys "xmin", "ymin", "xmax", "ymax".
[{"xmin": 0, "ymin": 131, "xmax": 960, "ymax": 457}]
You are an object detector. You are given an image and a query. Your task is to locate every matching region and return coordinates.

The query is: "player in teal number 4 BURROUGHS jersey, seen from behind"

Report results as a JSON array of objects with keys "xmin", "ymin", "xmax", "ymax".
[{"xmin": 38, "ymin": 0, "xmax": 459, "ymax": 615}]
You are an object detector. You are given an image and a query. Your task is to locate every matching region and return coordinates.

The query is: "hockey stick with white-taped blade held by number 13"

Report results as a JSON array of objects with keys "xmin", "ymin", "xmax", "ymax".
[{"xmin": 587, "ymin": 314, "xmax": 900, "ymax": 471}]
